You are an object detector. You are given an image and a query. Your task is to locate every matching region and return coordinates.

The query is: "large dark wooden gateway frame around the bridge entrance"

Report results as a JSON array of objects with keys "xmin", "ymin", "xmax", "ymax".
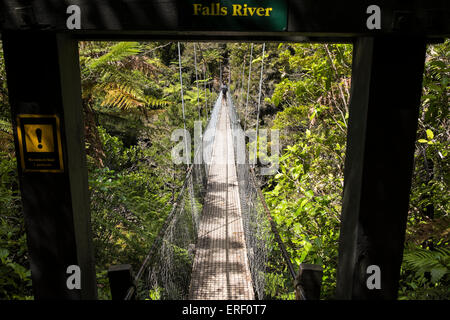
[{"xmin": 0, "ymin": 0, "xmax": 450, "ymax": 299}]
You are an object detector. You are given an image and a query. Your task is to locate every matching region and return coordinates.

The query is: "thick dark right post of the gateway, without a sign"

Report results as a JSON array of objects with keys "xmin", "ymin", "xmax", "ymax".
[{"xmin": 336, "ymin": 37, "xmax": 426, "ymax": 299}]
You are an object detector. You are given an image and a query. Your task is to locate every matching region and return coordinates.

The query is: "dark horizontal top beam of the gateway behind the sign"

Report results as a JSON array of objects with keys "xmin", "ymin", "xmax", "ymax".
[{"xmin": 0, "ymin": 0, "xmax": 450, "ymax": 39}]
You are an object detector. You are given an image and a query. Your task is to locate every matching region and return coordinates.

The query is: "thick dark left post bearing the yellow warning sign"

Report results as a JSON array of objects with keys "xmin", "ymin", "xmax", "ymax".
[{"xmin": 2, "ymin": 31, "xmax": 97, "ymax": 299}]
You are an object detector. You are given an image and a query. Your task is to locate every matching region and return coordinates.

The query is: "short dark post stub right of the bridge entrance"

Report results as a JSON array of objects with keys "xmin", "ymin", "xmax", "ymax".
[{"xmin": 295, "ymin": 263, "xmax": 323, "ymax": 300}]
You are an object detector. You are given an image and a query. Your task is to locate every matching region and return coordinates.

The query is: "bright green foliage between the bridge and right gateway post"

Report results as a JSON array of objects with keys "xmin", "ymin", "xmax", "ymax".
[{"xmin": 265, "ymin": 44, "xmax": 351, "ymax": 299}]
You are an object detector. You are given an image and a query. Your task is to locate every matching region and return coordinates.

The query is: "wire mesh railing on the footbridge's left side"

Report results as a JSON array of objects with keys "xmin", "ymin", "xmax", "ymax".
[{"xmin": 126, "ymin": 155, "xmax": 206, "ymax": 300}]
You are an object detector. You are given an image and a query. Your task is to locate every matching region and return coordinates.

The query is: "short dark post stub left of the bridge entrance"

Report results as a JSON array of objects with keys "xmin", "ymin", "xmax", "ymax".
[{"xmin": 108, "ymin": 264, "xmax": 136, "ymax": 300}]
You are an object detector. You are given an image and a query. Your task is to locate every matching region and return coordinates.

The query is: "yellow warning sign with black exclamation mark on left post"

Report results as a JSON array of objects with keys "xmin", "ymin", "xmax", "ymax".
[{"xmin": 17, "ymin": 114, "xmax": 64, "ymax": 172}]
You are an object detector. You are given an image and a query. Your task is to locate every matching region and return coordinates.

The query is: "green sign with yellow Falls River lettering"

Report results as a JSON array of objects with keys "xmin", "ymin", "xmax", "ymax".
[{"xmin": 179, "ymin": 0, "xmax": 287, "ymax": 31}]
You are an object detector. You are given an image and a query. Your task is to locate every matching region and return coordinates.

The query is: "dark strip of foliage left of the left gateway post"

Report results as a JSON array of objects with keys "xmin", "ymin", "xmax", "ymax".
[{"xmin": 0, "ymin": 42, "xmax": 32, "ymax": 300}]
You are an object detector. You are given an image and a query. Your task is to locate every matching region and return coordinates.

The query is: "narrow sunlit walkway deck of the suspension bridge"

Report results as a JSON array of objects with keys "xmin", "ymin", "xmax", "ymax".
[{"xmin": 189, "ymin": 100, "xmax": 254, "ymax": 300}]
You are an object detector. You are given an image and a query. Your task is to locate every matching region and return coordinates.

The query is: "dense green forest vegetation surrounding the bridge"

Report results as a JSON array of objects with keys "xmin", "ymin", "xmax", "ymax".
[{"xmin": 0, "ymin": 41, "xmax": 450, "ymax": 299}]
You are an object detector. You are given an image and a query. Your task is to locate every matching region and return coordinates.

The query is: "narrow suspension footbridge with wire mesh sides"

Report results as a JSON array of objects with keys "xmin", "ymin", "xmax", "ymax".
[{"xmin": 127, "ymin": 89, "xmax": 295, "ymax": 300}]
